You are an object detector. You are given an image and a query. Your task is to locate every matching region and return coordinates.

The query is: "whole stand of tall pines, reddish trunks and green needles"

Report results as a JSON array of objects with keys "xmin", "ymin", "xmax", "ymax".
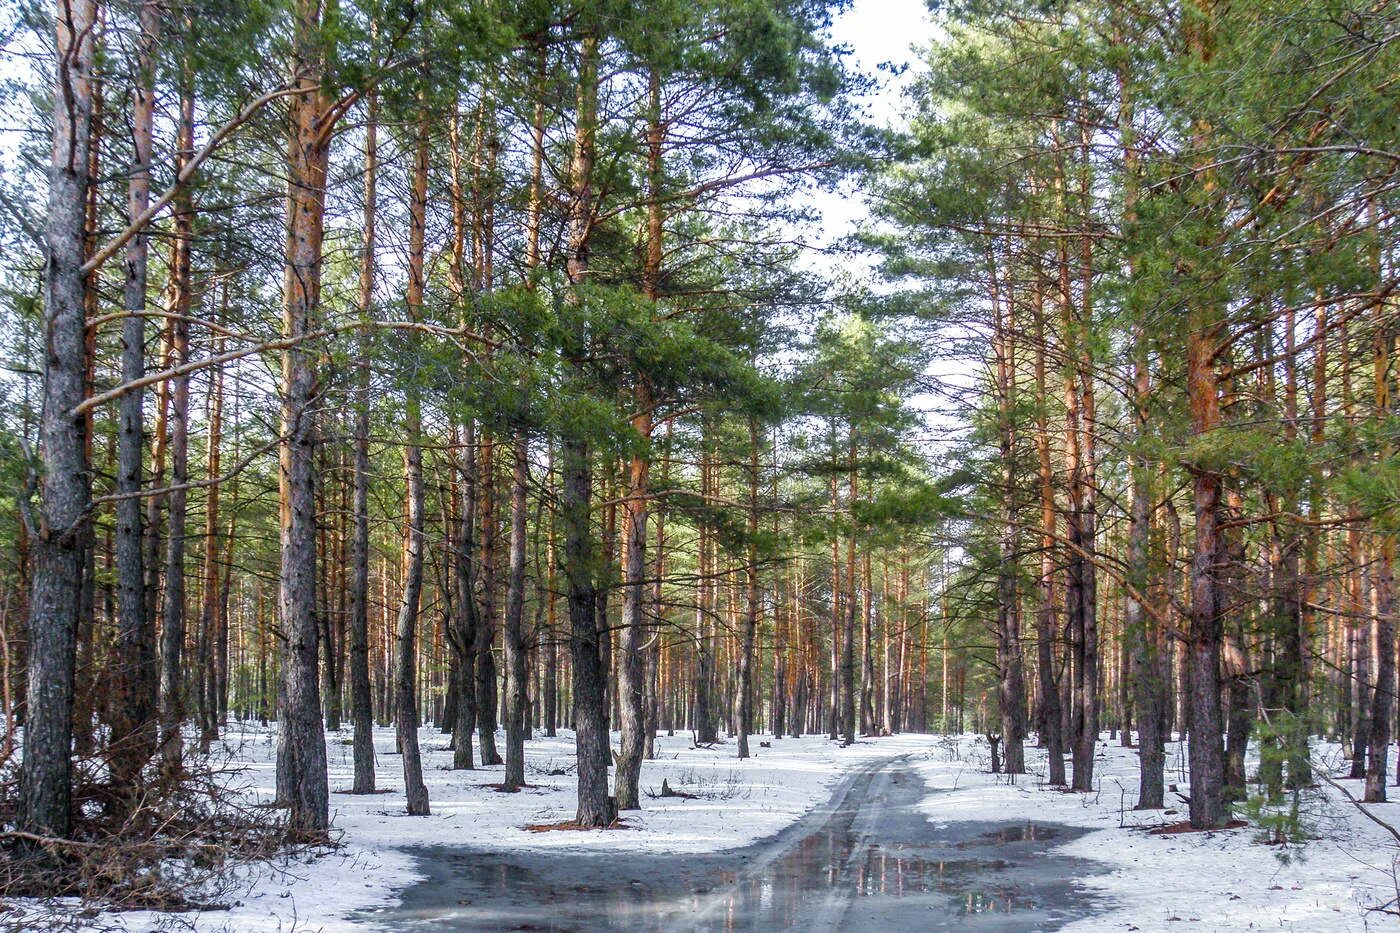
[{"xmin": 0, "ymin": 0, "xmax": 1400, "ymax": 913}]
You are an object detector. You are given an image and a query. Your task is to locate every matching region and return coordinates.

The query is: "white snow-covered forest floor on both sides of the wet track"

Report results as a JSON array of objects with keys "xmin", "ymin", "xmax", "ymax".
[{"xmin": 30, "ymin": 724, "xmax": 1400, "ymax": 933}]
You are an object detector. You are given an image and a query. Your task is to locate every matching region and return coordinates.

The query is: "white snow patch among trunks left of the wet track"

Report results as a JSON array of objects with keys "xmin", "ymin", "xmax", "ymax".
[{"xmin": 105, "ymin": 723, "xmax": 931, "ymax": 933}]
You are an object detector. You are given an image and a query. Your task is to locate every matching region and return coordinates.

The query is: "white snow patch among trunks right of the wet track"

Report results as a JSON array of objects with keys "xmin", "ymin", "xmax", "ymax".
[{"xmin": 917, "ymin": 735, "xmax": 1400, "ymax": 933}]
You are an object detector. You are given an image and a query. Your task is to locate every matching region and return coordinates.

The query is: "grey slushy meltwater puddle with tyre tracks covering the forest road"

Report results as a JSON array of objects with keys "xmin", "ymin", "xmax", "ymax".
[{"xmin": 363, "ymin": 762, "xmax": 1102, "ymax": 933}]
